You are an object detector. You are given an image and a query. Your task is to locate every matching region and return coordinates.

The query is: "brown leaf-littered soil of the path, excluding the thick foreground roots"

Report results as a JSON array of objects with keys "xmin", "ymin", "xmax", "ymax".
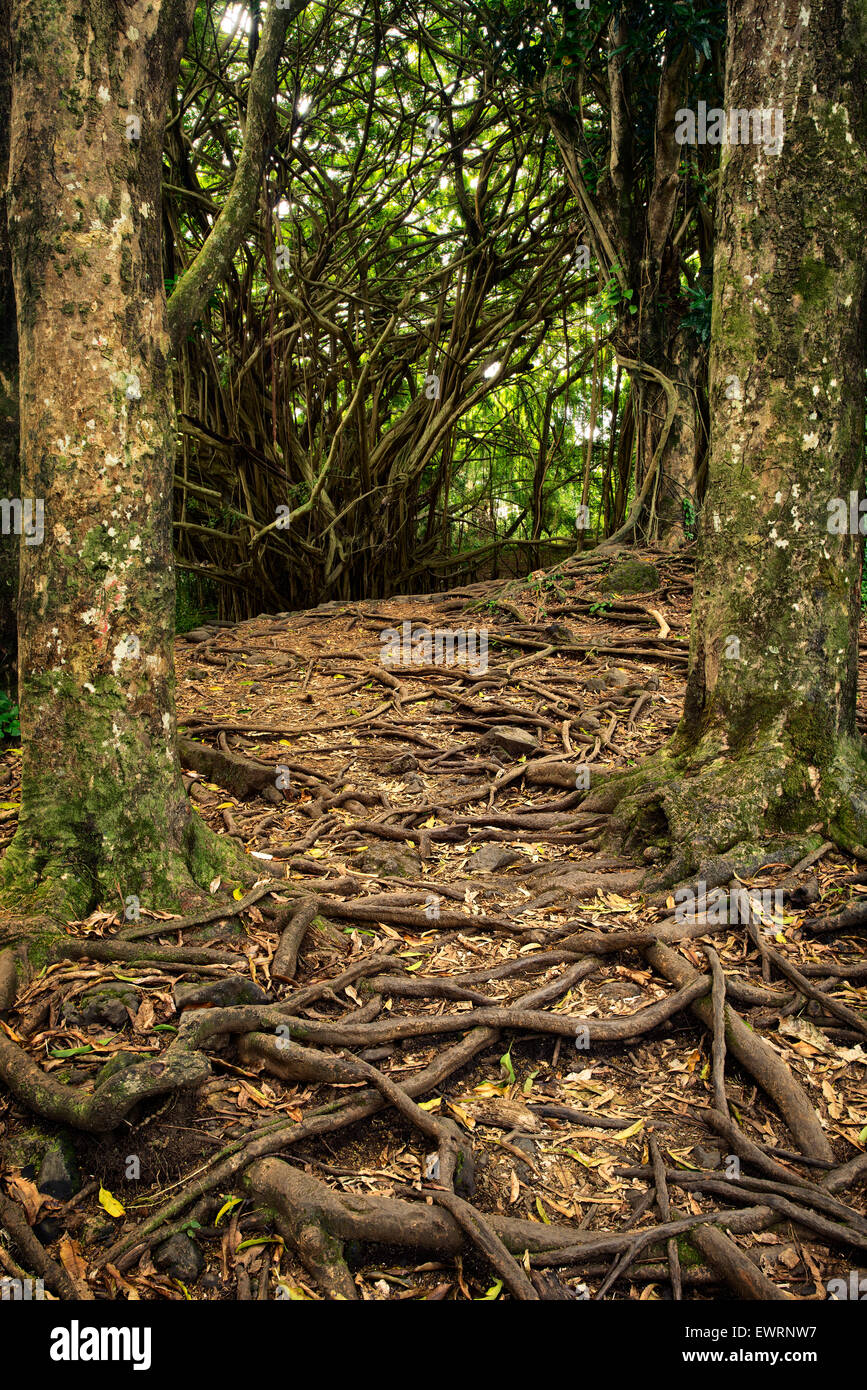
[{"xmin": 0, "ymin": 552, "xmax": 867, "ymax": 1300}]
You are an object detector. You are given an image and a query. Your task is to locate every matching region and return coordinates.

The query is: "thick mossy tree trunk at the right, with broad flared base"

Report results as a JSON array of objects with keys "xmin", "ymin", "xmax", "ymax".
[{"xmin": 597, "ymin": 0, "xmax": 867, "ymax": 873}]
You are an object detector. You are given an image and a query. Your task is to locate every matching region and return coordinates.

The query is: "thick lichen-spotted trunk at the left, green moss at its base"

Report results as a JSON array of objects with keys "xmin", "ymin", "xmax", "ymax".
[{"xmin": 0, "ymin": 0, "xmax": 247, "ymax": 916}]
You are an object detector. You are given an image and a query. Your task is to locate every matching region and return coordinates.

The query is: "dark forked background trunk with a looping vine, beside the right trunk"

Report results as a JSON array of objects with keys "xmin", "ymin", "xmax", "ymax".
[{"xmin": 542, "ymin": 20, "xmax": 706, "ymax": 550}]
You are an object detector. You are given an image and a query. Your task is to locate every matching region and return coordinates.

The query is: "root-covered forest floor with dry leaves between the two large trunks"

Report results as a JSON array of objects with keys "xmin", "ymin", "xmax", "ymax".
[{"xmin": 0, "ymin": 552, "xmax": 867, "ymax": 1300}]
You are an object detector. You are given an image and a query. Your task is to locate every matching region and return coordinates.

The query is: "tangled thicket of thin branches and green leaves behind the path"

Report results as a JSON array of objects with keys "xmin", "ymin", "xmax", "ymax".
[{"xmin": 164, "ymin": 0, "xmax": 724, "ymax": 628}]
